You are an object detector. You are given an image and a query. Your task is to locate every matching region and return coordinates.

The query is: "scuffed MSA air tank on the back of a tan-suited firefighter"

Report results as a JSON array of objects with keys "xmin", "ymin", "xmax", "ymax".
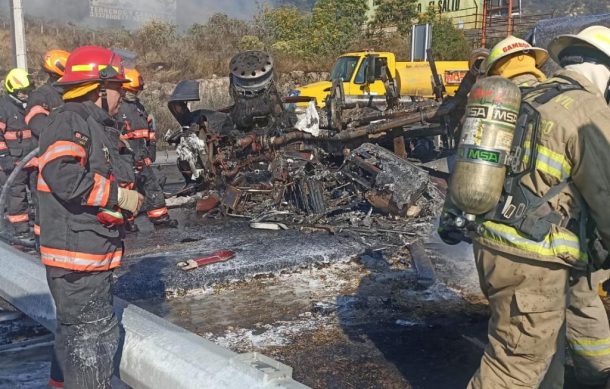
[{"xmin": 449, "ymin": 76, "xmax": 521, "ymax": 220}]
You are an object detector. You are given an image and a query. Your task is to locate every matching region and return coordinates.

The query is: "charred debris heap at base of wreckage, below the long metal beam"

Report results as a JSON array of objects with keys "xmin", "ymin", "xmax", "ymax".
[{"xmin": 180, "ymin": 143, "xmax": 443, "ymax": 246}]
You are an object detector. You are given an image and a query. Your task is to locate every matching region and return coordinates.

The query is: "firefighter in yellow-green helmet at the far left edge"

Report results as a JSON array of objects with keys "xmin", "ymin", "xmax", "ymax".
[{"xmin": 0, "ymin": 68, "xmax": 36, "ymax": 238}]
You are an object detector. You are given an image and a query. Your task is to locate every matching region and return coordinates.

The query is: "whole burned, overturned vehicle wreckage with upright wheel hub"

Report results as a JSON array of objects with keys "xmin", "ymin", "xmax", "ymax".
[{"xmin": 165, "ymin": 51, "xmax": 450, "ymax": 241}]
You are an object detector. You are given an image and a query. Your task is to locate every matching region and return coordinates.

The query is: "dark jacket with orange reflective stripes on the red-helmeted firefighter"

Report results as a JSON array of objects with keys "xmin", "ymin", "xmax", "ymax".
[{"xmin": 38, "ymin": 102, "xmax": 134, "ymax": 271}]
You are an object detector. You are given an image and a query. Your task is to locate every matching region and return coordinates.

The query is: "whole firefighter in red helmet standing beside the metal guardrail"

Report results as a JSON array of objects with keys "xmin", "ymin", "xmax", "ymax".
[{"xmin": 38, "ymin": 46, "xmax": 144, "ymax": 389}]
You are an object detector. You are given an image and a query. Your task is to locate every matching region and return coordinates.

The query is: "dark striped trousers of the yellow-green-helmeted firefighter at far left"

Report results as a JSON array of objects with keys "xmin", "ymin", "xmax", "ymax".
[{"xmin": 7, "ymin": 168, "xmax": 38, "ymax": 233}]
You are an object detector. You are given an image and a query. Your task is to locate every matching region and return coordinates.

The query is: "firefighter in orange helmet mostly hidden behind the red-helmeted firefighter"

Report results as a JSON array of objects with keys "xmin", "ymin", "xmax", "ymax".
[{"xmin": 25, "ymin": 49, "xmax": 70, "ymax": 237}]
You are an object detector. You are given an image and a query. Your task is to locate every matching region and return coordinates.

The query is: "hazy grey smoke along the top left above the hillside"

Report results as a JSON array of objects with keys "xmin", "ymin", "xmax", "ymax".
[{"xmin": 0, "ymin": 0, "xmax": 271, "ymax": 29}]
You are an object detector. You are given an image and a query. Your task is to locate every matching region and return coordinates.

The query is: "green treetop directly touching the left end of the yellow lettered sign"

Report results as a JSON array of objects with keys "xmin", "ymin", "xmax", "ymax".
[{"xmin": 369, "ymin": 0, "xmax": 417, "ymax": 36}]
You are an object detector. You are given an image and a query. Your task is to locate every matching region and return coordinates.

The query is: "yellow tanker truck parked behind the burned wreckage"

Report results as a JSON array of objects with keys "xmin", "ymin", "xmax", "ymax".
[{"xmin": 292, "ymin": 51, "xmax": 468, "ymax": 108}]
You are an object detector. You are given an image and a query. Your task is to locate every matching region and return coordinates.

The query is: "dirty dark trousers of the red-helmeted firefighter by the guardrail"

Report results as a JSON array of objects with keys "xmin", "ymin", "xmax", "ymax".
[{"xmin": 46, "ymin": 266, "xmax": 119, "ymax": 389}]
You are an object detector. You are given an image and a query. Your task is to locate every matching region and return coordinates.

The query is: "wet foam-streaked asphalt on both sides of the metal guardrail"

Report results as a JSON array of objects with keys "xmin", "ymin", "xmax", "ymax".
[{"xmin": 0, "ymin": 183, "xmax": 600, "ymax": 389}]
